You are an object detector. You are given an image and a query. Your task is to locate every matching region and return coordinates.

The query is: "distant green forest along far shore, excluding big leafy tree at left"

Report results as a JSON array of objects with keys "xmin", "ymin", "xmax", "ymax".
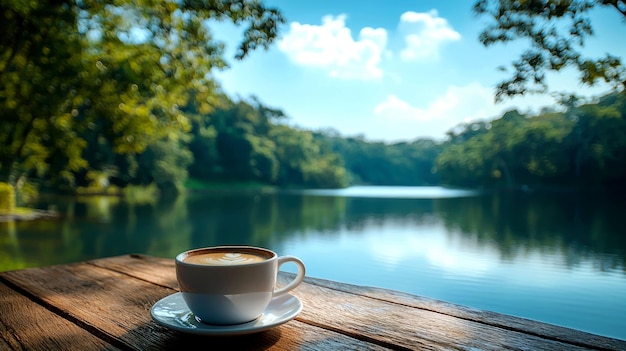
[{"xmin": 9, "ymin": 89, "xmax": 626, "ymax": 197}]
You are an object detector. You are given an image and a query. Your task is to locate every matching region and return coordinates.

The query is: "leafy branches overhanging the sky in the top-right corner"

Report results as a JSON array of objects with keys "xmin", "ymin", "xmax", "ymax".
[{"xmin": 474, "ymin": 0, "xmax": 626, "ymax": 101}]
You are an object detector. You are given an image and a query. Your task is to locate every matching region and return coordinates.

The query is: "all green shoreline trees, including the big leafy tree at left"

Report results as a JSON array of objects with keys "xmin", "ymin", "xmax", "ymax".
[{"xmin": 0, "ymin": 0, "xmax": 626, "ymax": 199}]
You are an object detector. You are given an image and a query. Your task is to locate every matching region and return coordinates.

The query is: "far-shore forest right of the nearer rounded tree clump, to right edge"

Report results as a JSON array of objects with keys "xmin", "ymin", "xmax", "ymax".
[{"xmin": 316, "ymin": 92, "xmax": 626, "ymax": 189}]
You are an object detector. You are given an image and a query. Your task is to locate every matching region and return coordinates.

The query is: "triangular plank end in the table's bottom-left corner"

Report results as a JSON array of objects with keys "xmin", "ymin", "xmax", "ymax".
[{"xmin": 0, "ymin": 282, "xmax": 119, "ymax": 351}]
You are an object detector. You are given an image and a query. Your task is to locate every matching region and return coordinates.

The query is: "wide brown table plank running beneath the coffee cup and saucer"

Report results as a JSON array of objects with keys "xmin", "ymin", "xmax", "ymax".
[{"xmin": 0, "ymin": 256, "xmax": 386, "ymax": 350}]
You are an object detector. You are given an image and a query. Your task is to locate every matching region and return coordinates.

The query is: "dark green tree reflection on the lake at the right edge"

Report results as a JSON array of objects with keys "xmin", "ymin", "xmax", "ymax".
[{"xmin": 436, "ymin": 193, "xmax": 626, "ymax": 271}]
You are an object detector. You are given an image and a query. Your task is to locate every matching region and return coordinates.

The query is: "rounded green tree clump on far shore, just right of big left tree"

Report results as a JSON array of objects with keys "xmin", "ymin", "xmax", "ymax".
[{"xmin": 183, "ymin": 97, "xmax": 347, "ymax": 191}]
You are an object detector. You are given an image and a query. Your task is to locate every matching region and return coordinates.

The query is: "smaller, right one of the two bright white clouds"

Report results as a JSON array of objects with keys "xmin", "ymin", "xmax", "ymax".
[{"xmin": 399, "ymin": 10, "xmax": 461, "ymax": 61}]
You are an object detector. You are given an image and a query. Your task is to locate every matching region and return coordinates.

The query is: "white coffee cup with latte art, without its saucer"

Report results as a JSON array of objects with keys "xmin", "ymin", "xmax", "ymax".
[{"xmin": 176, "ymin": 246, "xmax": 306, "ymax": 325}]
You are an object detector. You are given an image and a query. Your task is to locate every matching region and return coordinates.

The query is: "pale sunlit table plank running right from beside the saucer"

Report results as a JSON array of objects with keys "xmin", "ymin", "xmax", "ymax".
[{"xmin": 280, "ymin": 276, "xmax": 594, "ymax": 351}]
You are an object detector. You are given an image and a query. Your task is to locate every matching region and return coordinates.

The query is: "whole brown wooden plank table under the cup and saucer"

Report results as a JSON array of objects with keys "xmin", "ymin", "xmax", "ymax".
[{"xmin": 0, "ymin": 255, "xmax": 626, "ymax": 351}]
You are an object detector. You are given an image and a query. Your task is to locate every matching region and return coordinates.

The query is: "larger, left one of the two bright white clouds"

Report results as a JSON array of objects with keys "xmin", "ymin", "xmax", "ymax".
[{"xmin": 278, "ymin": 15, "xmax": 387, "ymax": 79}]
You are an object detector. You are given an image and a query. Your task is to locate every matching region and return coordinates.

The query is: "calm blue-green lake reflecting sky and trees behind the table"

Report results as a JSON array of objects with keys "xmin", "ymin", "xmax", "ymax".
[{"xmin": 0, "ymin": 187, "xmax": 626, "ymax": 340}]
